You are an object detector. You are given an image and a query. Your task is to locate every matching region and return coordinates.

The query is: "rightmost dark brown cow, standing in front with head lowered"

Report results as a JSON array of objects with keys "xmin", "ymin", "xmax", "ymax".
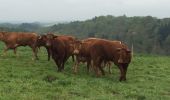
[{"xmin": 90, "ymin": 39, "xmax": 131, "ymax": 81}]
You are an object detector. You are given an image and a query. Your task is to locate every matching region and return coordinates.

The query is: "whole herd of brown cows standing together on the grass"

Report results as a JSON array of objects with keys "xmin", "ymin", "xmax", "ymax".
[{"xmin": 0, "ymin": 32, "xmax": 131, "ymax": 81}]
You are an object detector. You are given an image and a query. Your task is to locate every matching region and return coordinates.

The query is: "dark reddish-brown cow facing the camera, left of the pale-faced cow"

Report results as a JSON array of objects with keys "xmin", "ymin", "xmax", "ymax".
[{"xmin": 39, "ymin": 33, "xmax": 76, "ymax": 72}]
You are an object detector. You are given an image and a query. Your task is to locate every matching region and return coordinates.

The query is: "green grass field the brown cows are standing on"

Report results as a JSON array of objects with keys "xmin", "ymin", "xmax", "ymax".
[{"xmin": 0, "ymin": 44, "xmax": 170, "ymax": 100}]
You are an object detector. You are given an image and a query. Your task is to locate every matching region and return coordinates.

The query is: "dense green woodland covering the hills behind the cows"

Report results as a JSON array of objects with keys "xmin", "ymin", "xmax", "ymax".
[{"xmin": 0, "ymin": 15, "xmax": 170, "ymax": 55}]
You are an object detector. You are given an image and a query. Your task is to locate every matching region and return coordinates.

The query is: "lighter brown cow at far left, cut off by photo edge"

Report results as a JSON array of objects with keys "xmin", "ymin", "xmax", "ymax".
[{"xmin": 0, "ymin": 32, "xmax": 38, "ymax": 59}]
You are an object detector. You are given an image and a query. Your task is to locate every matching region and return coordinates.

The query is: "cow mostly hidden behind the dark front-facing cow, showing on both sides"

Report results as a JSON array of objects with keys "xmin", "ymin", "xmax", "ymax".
[{"xmin": 37, "ymin": 33, "xmax": 76, "ymax": 61}]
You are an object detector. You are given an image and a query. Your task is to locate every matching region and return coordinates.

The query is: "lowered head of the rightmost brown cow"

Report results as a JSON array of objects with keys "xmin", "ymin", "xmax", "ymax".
[{"xmin": 117, "ymin": 48, "xmax": 131, "ymax": 64}]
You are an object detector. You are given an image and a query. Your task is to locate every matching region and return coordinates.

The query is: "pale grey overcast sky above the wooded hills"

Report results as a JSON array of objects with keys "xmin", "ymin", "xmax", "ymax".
[{"xmin": 0, "ymin": 0, "xmax": 170, "ymax": 22}]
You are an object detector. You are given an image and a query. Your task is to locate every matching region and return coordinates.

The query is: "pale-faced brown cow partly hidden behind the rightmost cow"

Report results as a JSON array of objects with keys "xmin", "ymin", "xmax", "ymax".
[{"xmin": 73, "ymin": 38, "xmax": 120, "ymax": 73}]
